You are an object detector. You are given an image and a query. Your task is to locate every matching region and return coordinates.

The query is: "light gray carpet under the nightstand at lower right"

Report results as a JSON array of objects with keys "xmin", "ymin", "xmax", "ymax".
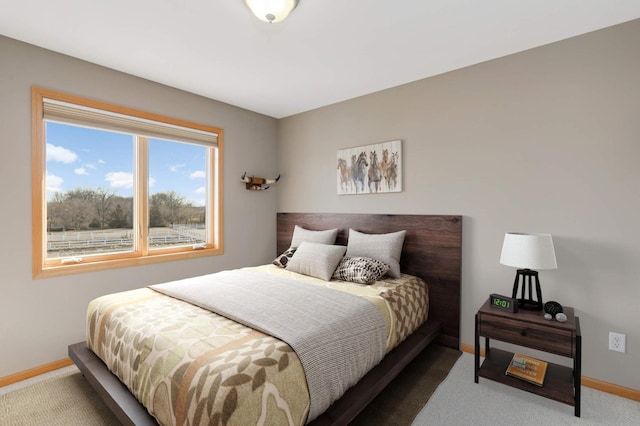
[{"xmin": 413, "ymin": 353, "xmax": 640, "ymax": 426}]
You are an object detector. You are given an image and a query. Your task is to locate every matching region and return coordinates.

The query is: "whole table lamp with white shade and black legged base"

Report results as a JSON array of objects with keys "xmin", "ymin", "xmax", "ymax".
[{"xmin": 500, "ymin": 232, "xmax": 558, "ymax": 311}]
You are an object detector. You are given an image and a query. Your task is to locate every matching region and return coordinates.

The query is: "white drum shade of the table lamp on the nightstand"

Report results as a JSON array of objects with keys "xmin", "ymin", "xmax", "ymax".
[{"xmin": 500, "ymin": 232, "xmax": 558, "ymax": 270}]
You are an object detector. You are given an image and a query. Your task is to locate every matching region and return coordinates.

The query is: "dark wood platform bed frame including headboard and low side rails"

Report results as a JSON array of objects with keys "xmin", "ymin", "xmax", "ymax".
[{"xmin": 69, "ymin": 213, "xmax": 462, "ymax": 426}]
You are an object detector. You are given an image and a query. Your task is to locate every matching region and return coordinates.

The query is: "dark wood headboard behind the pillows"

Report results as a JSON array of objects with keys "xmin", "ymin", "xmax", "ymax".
[{"xmin": 277, "ymin": 213, "xmax": 462, "ymax": 349}]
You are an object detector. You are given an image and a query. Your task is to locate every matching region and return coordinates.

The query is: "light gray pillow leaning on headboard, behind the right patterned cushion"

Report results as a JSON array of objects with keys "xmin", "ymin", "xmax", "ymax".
[{"xmin": 346, "ymin": 229, "xmax": 407, "ymax": 278}]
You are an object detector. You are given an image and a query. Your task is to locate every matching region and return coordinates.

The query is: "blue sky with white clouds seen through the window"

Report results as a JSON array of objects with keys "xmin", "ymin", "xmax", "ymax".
[{"xmin": 46, "ymin": 122, "xmax": 206, "ymax": 206}]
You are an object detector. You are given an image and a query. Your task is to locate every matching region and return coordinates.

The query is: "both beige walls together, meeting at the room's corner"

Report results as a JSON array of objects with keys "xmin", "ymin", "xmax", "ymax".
[{"xmin": 0, "ymin": 21, "xmax": 640, "ymax": 389}]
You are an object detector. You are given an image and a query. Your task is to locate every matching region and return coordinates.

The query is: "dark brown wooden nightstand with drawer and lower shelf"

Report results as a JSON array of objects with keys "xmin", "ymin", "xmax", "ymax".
[{"xmin": 474, "ymin": 300, "xmax": 582, "ymax": 417}]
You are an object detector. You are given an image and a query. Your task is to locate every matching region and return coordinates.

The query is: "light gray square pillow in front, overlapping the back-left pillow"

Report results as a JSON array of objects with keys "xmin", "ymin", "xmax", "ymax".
[{"xmin": 287, "ymin": 241, "xmax": 347, "ymax": 281}]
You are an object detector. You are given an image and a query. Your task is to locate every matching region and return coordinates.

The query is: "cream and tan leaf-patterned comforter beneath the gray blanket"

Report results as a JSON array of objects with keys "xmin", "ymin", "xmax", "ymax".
[{"xmin": 87, "ymin": 265, "xmax": 428, "ymax": 425}]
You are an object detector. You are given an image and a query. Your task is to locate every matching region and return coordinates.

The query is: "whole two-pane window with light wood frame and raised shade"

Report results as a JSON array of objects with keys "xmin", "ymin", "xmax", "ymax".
[{"xmin": 32, "ymin": 87, "xmax": 223, "ymax": 278}]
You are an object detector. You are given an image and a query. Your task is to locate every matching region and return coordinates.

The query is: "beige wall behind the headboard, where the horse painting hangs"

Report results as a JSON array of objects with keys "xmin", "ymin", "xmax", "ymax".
[{"xmin": 278, "ymin": 20, "xmax": 640, "ymax": 390}]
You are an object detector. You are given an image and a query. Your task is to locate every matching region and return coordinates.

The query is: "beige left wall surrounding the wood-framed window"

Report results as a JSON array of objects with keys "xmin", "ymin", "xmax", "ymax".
[{"xmin": 0, "ymin": 37, "xmax": 277, "ymax": 377}]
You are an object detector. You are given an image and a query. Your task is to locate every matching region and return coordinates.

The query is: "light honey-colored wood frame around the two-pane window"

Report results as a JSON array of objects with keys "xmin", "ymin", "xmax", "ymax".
[{"xmin": 31, "ymin": 86, "xmax": 224, "ymax": 278}]
